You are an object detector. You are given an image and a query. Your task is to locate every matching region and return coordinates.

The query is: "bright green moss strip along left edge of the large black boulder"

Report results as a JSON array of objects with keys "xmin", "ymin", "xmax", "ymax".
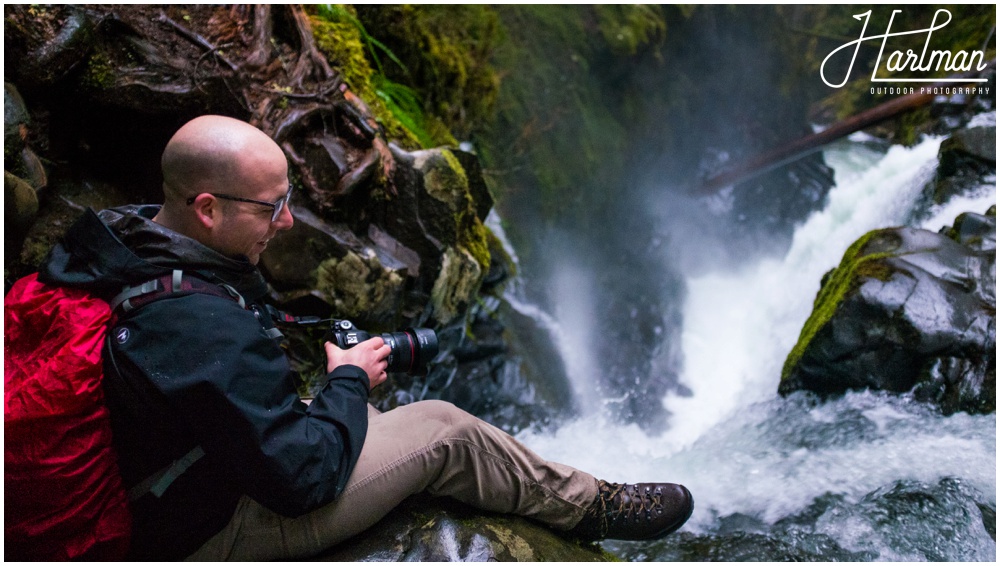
[{"xmin": 781, "ymin": 229, "xmax": 895, "ymax": 382}]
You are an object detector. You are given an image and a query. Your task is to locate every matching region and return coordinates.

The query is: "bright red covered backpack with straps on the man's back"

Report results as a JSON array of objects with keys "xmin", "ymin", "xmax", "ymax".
[{"xmin": 3, "ymin": 271, "xmax": 242, "ymax": 561}]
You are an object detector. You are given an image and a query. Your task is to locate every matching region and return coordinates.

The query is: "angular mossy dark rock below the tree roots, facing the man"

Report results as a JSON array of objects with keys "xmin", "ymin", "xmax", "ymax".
[{"xmin": 261, "ymin": 148, "xmax": 492, "ymax": 331}]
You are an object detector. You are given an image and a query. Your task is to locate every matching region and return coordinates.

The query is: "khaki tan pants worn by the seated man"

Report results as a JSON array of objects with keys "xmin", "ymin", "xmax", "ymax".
[{"xmin": 188, "ymin": 401, "xmax": 597, "ymax": 561}]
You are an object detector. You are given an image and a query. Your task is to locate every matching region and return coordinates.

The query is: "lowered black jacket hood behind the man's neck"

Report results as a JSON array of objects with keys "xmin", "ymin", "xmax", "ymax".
[{"xmin": 38, "ymin": 205, "xmax": 267, "ymax": 300}]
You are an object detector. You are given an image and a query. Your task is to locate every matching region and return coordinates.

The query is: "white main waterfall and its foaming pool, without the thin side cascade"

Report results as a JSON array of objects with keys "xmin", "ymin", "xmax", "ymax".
[{"xmin": 519, "ymin": 131, "xmax": 996, "ymax": 560}]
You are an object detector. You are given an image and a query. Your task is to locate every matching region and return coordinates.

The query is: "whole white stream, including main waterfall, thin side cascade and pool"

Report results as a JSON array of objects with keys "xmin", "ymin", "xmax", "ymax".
[{"xmin": 508, "ymin": 125, "xmax": 996, "ymax": 561}]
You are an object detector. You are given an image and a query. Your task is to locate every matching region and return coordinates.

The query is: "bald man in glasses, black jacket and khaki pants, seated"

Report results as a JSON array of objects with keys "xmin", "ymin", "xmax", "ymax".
[{"xmin": 39, "ymin": 116, "xmax": 693, "ymax": 560}]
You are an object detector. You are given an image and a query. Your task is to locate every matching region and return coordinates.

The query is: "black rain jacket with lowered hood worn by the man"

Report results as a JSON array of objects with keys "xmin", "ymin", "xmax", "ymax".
[{"xmin": 39, "ymin": 206, "xmax": 369, "ymax": 560}]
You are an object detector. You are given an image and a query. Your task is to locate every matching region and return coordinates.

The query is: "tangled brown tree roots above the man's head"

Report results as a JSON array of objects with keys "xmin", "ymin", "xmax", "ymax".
[{"xmin": 10, "ymin": 4, "xmax": 396, "ymax": 221}]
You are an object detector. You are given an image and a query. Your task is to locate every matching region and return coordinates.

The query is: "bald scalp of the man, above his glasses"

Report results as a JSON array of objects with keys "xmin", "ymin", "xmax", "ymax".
[{"xmin": 161, "ymin": 116, "xmax": 287, "ymax": 201}]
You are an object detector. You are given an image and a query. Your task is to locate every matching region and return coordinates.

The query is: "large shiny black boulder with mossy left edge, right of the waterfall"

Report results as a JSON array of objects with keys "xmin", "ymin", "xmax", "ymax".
[{"xmin": 779, "ymin": 210, "xmax": 996, "ymax": 413}]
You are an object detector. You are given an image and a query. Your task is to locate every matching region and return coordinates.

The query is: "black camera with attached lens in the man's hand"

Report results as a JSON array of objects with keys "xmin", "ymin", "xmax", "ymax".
[{"xmin": 325, "ymin": 320, "xmax": 438, "ymax": 375}]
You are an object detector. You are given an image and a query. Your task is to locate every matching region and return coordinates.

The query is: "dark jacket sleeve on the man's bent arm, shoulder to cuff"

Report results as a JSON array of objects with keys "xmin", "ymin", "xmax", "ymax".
[{"xmin": 110, "ymin": 294, "xmax": 369, "ymax": 517}]
